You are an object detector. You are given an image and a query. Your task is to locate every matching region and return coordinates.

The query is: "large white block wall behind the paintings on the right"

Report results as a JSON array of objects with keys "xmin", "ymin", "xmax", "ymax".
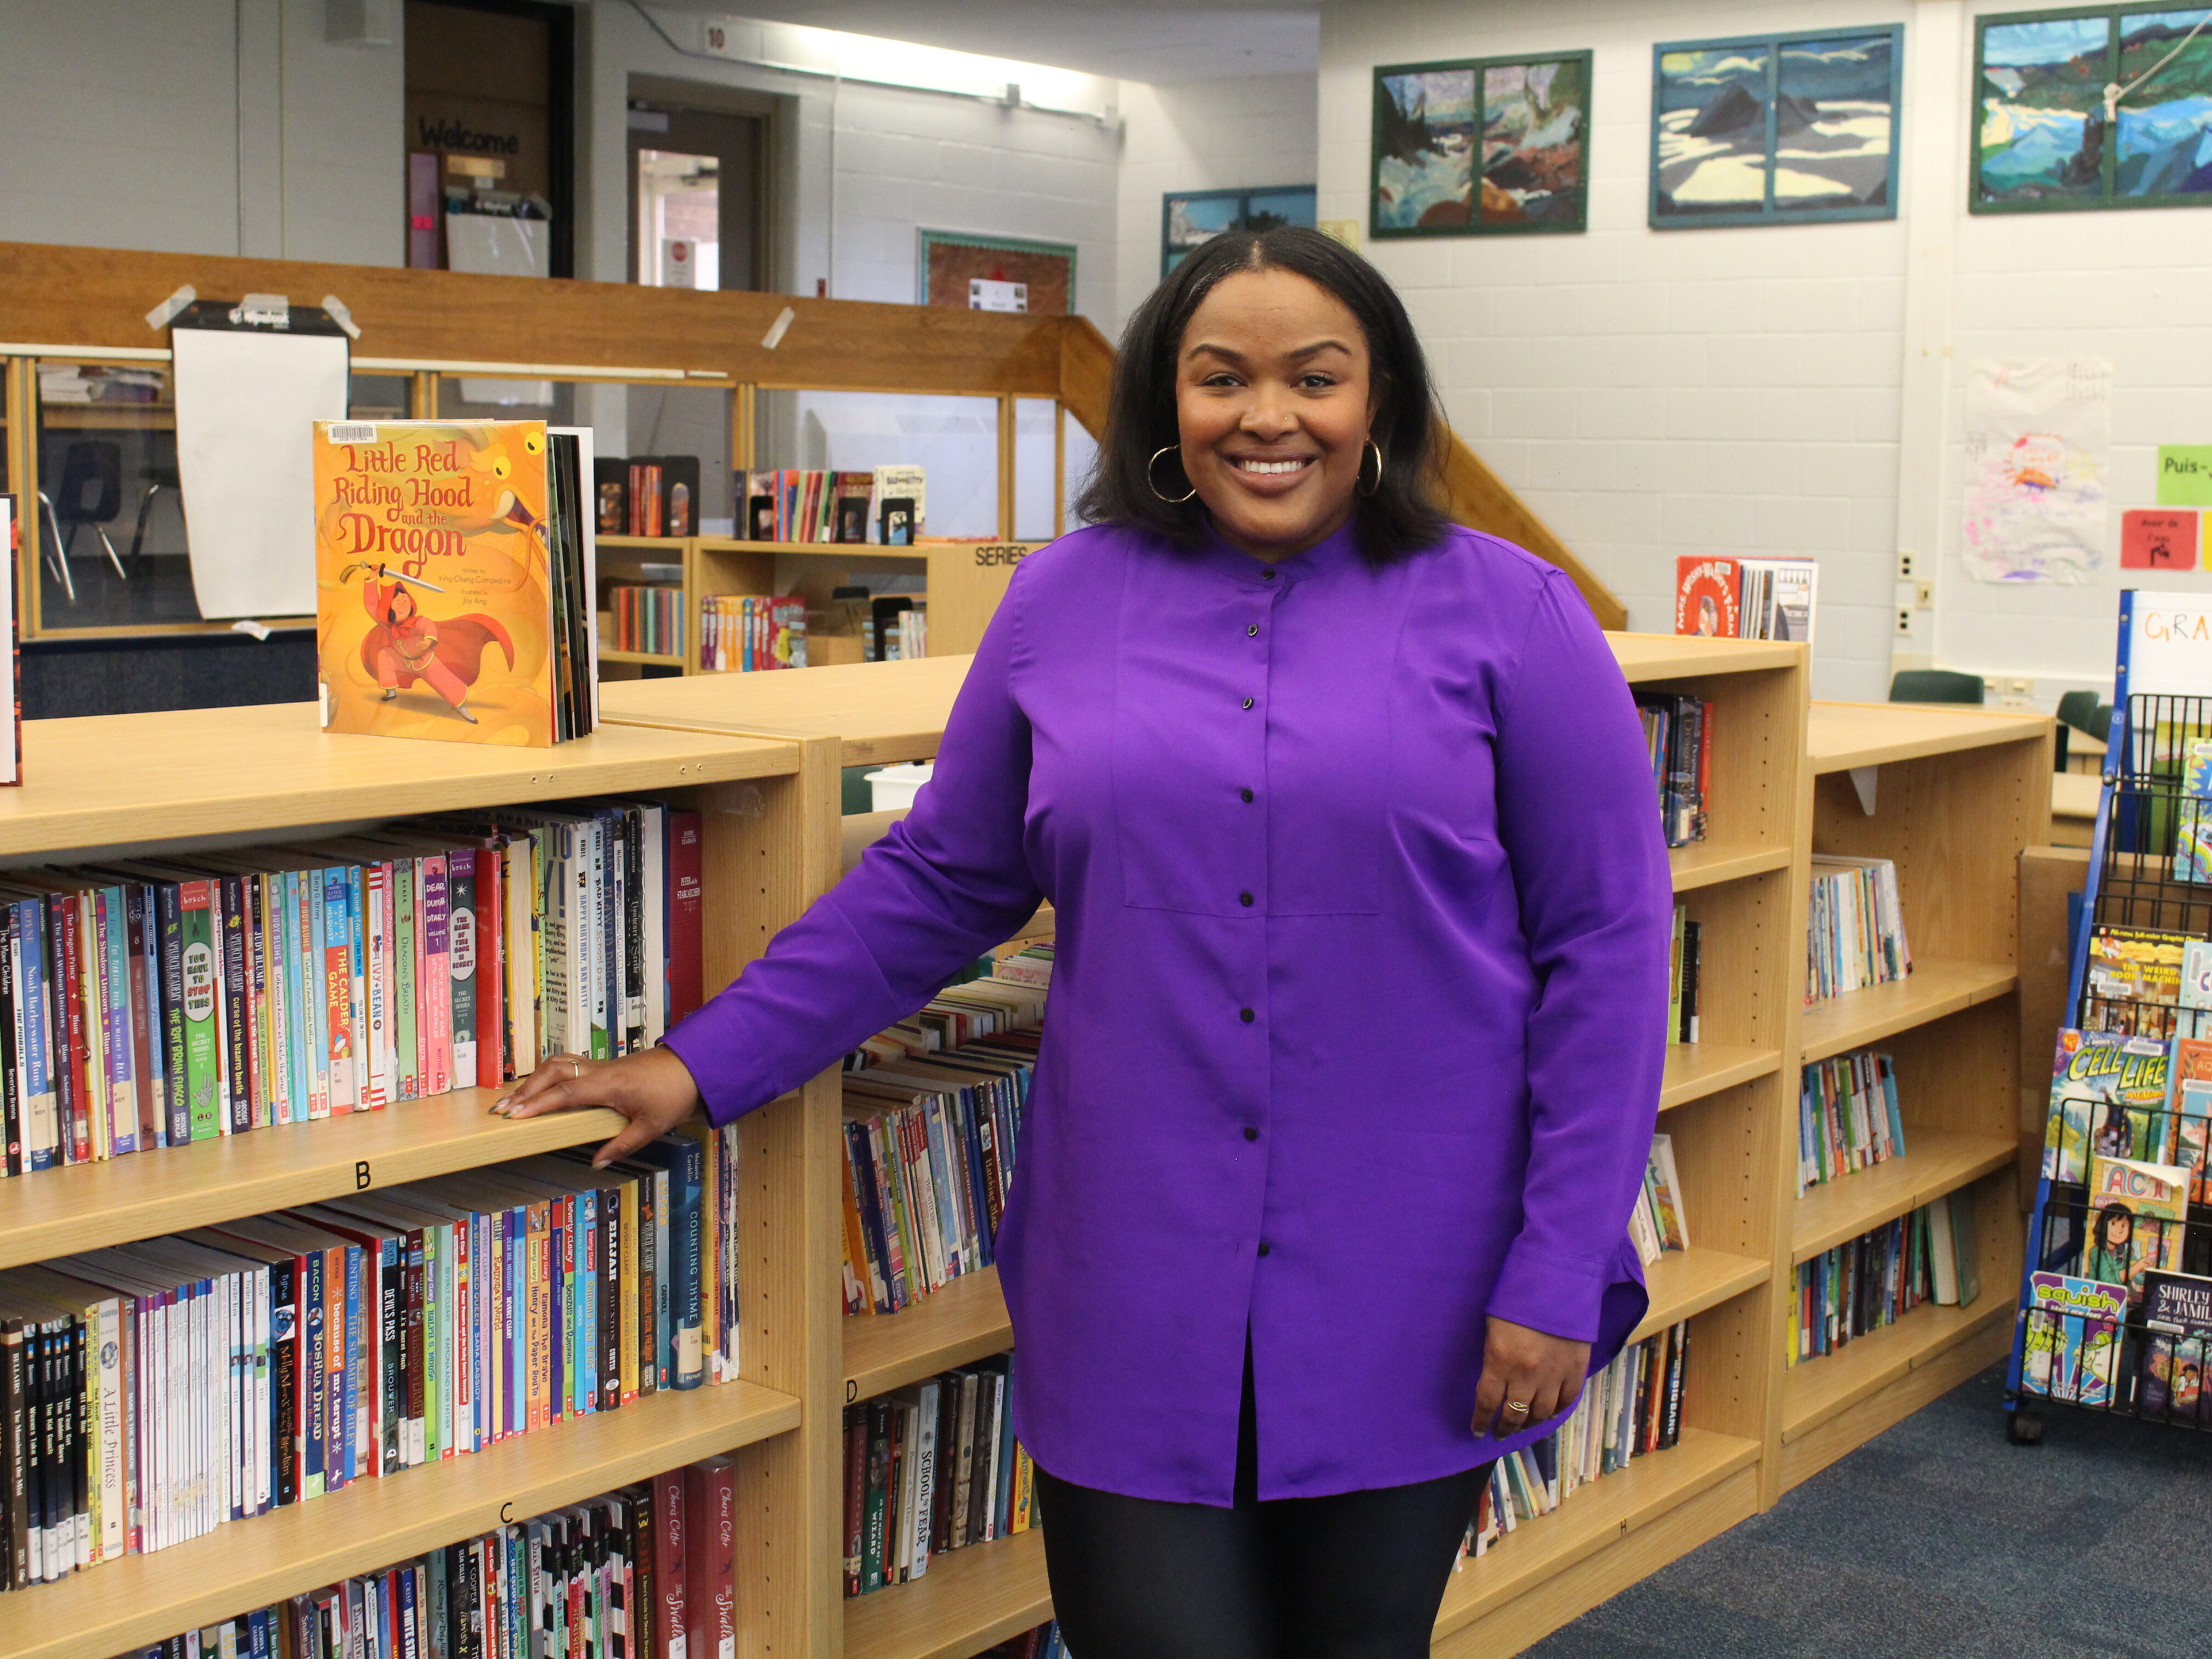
[{"xmin": 1321, "ymin": 0, "xmax": 2212, "ymax": 706}]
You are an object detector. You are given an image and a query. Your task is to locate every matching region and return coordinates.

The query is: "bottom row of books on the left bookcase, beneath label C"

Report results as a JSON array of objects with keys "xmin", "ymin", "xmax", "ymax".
[{"xmin": 124, "ymin": 1458, "xmax": 739, "ymax": 1659}]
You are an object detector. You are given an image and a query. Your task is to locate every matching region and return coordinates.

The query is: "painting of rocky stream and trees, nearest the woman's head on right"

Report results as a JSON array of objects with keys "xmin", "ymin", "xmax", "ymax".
[{"xmin": 1367, "ymin": 51, "xmax": 1590, "ymax": 236}]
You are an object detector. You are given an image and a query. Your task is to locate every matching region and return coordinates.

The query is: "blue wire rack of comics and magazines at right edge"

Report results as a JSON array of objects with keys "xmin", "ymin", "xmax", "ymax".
[{"xmin": 2004, "ymin": 690, "xmax": 2212, "ymax": 1444}]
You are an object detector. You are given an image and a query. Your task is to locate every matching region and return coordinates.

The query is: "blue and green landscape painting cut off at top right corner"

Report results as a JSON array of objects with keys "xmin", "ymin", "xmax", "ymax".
[{"xmin": 1966, "ymin": 4, "xmax": 2212, "ymax": 212}]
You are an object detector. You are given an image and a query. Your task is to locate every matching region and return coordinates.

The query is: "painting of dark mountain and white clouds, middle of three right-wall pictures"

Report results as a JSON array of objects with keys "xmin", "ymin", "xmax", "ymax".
[{"xmin": 1650, "ymin": 24, "xmax": 1905, "ymax": 230}]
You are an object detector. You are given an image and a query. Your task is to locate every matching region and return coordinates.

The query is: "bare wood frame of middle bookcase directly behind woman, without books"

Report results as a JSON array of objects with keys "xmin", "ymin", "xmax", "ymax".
[{"xmin": 602, "ymin": 635, "xmax": 1807, "ymax": 1659}]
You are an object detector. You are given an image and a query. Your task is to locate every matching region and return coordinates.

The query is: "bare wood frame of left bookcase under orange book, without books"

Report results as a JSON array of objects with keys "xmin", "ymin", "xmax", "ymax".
[{"xmin": 0, "ymin": 703, "xmax": 836, "ymax": 1659}]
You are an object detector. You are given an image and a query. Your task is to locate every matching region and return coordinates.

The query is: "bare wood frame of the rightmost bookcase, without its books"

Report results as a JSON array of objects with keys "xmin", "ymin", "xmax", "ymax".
[{"xmin": 1772, "ymin": 703, "xmax": 2053, "ymax": 1491}]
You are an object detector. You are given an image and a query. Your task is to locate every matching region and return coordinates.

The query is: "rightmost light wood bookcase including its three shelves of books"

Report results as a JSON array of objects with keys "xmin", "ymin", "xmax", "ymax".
[{"xmin": 1772, "ymin": 703, "xmax": 2051, "ymax": 1489}]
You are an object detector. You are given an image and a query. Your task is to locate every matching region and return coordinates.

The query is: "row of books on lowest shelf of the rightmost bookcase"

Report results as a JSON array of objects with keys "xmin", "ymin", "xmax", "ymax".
[{"xmin": 1783, "ymin": 1188, "xmax": 1982, "ymax": 1365}]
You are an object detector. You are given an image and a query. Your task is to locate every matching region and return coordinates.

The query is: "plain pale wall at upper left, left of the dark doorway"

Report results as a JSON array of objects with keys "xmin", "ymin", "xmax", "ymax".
[{"xmin": 0, "ymin": 0, "xmax": 405, "ymax": 264}]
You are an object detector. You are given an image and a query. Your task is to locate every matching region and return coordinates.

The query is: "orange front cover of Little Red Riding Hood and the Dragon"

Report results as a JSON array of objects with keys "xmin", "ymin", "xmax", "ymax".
[{"xmin": 314, "ymin": 420, "xmax": 553, "ymax": 748}]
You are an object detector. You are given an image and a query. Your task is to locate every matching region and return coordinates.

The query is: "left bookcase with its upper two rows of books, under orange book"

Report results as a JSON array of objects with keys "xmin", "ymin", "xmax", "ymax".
[{"xmin": 0, "ymin": 703, "xmax": 836, "ymax": 1659}]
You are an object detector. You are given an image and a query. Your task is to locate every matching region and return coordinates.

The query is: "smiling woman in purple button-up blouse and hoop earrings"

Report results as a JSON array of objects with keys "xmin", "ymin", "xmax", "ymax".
[{"xmin": 504, "ymin": 230, "xmax": 1672, "ymax": 1659}]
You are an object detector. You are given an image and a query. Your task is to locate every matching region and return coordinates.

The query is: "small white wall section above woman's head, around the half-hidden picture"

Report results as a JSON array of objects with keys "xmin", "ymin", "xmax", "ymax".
[{"xmin": 1124, "ymin": 75, "xmax": 1321, "ymax": 334}]
